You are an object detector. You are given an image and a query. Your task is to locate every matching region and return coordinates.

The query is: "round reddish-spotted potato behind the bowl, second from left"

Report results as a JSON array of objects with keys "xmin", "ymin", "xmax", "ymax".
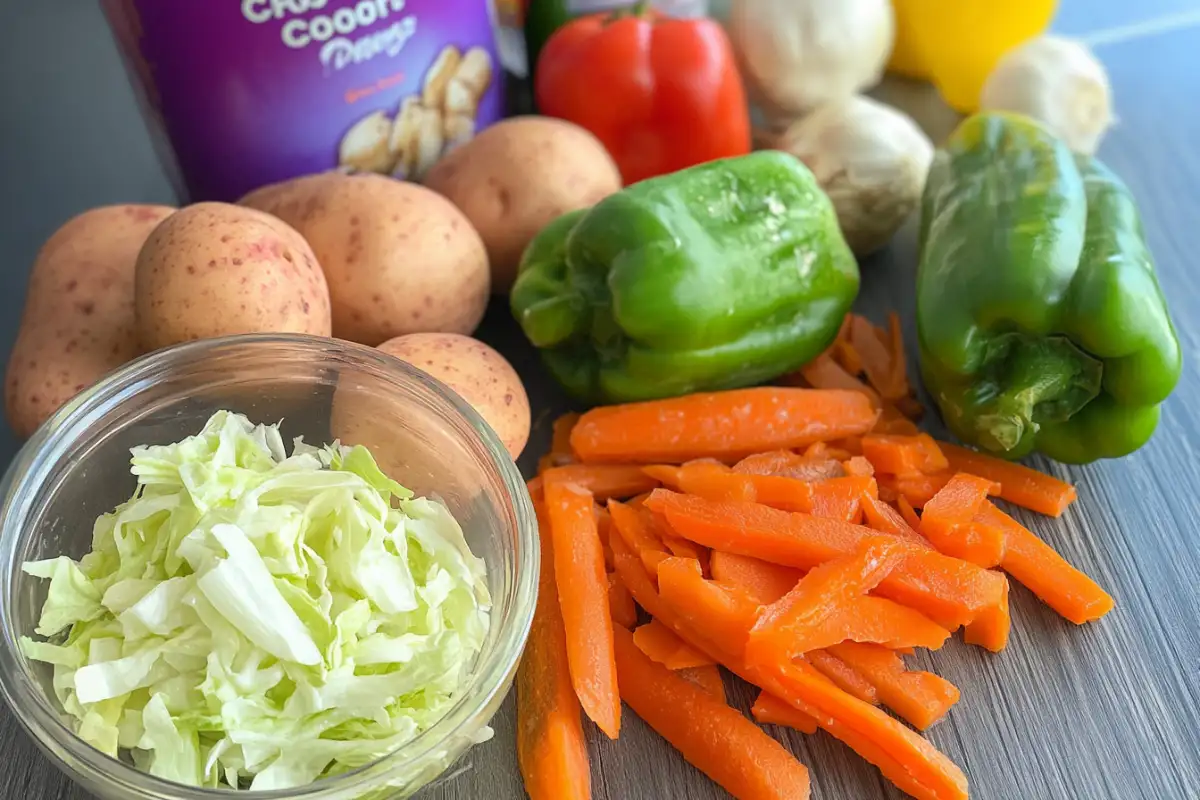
[{"xmin": 134, "ymin": 203, "xmax": 330, "ymax": 351}]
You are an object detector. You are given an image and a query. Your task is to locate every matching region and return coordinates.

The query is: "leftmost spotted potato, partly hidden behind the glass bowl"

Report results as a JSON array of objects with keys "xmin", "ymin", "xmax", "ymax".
[{"xmin": 5, "ymin": 205, "xmax": 175, "ymax": 438}]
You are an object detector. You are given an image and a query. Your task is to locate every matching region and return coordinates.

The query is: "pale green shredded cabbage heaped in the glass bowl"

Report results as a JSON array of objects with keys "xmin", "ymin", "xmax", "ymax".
[{"xmin": 20, "ymin": 411, "xmax": 491, "ymax": 789}]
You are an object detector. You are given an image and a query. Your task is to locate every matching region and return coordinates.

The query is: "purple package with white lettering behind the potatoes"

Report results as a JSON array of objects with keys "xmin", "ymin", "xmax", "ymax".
[{"xmin": 103, "ymin": 0, "xmax": 504, "ymax": 201}]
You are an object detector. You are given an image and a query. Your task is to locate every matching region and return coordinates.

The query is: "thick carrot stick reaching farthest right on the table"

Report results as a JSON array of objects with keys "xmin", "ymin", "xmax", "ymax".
[{"xmin": 974, "ymin": 503, "xmax": 1112, "ymax": 625}]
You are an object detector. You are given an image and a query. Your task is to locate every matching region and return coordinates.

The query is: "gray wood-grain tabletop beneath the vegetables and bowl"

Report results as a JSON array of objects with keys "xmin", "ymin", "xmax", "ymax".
[{"xmin": 0, "ymin": 0, "xmax": 1200, "ymax": 800}]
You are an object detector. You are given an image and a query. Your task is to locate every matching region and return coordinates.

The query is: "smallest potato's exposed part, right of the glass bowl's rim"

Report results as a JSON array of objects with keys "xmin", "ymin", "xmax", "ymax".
[{"xmin": 379, "ymin": 333, "xmax": 530, "ymax": 461}]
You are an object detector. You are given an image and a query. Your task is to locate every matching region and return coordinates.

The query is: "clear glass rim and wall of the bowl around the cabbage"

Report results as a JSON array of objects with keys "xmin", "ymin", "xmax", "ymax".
[{"xmin": 0, "ymin": 333, "xmax": 540, "ymax": 800}]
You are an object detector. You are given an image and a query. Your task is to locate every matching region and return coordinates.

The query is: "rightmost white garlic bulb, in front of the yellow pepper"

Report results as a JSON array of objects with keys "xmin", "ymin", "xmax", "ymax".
[{"xmin": 979, "ymin": 36, "xmax": 1112, "ymax": 155}]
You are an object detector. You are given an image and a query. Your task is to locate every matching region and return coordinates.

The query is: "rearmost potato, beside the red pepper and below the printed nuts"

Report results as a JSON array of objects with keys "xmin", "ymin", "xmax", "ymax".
[{"xmin": 424, "ymin": 116, "xmax": 620, "ymax": 293}]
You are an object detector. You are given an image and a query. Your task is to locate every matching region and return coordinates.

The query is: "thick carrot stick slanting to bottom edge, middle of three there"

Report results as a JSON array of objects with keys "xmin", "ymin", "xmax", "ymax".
[{"xmin": 614, "ymin": 630, "xmax": 809, "ymax": 800}]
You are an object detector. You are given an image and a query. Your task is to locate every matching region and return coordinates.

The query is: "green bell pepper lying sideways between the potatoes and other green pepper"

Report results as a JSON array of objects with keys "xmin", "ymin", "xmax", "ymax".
[{"xmin": 510, "ymin": 152, "xmax": 858, "ymax": 403}]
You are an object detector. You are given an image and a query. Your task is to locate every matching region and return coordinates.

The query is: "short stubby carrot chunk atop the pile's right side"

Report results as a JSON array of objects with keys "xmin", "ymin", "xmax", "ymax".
[{"xmin": 920, "ymin": 473, "xmax": 1004, "ymax": 569}]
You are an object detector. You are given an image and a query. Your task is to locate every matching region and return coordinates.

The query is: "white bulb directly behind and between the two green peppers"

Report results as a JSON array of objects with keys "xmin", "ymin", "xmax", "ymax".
[{"xmin": 774, "ymin": 95, "xmax": 934, "ymax": 257}]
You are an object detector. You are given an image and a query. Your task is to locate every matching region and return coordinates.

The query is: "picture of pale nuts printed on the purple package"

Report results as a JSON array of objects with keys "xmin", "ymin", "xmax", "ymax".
[{"xmin": 338, "ymin": 44, "xmax": 493, "ymax": 180}]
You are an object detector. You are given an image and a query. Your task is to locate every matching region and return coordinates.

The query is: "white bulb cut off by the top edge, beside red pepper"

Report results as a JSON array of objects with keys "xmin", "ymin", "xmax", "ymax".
[{"xmin": 728, "ymin": 0, "xmax": 895, "ymax": 121}]
